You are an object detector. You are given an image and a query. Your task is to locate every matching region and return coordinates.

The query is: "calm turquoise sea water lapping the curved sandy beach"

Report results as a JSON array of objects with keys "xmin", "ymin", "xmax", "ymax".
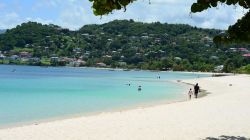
[{"xmin": 0, "ymin": 65, "xmax": 210, "ymax": 126}]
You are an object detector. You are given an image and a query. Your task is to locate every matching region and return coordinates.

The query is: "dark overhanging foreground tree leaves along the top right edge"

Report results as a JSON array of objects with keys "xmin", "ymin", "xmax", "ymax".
[{"xmin": 89, "ymin": 0, "xmax": 250, "ymax": 43}]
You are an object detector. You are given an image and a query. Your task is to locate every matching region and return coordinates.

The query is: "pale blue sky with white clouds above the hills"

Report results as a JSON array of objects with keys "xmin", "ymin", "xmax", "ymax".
[{"xmin": 0, "ymin": 0, "xmax": 246, "ymax": 30}]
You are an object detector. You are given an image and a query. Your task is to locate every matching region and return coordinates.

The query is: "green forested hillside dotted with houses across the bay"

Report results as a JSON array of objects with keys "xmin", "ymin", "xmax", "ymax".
[{"xmin": 0, "ymin": 20, "xmax": 250, "ymax": 72}]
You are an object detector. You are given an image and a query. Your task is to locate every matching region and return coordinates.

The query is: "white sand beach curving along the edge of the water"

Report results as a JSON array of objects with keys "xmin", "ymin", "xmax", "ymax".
[{"xmin": 0, "ymin": 75, "xmax": 250, "ymax": 140}]
